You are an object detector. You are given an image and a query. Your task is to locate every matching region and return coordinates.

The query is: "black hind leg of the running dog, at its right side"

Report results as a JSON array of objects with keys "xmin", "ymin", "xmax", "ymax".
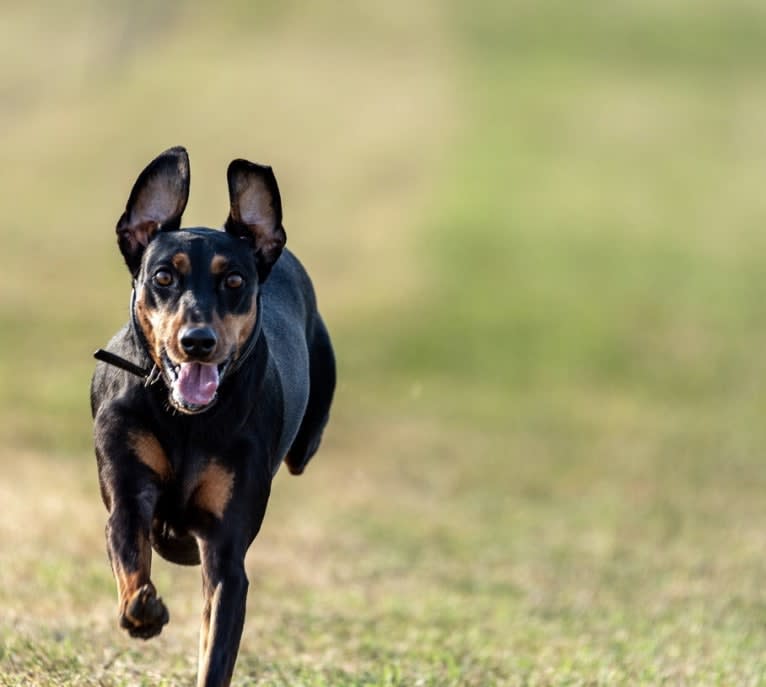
[{"xmin": 285, "ymin": 314, "xmax": 335, "ymax": 475}]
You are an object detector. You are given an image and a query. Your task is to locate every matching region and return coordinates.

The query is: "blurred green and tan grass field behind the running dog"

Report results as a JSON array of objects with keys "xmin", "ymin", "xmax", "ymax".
[{"xmin": 0, "ymin": 0, "xmax": 766, "ymax": 687}]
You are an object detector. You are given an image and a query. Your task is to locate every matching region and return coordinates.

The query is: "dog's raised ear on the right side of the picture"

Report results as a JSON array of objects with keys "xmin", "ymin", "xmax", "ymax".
[{"xmin": 230, "ymin": 160, "xmax": 287, "ymax": 282}]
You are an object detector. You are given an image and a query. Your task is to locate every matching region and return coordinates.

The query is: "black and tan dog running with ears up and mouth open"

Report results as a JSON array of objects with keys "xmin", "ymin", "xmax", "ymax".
[{"xmin": 91, "ymin": 148, "xmax": 335, "ymax": 687}]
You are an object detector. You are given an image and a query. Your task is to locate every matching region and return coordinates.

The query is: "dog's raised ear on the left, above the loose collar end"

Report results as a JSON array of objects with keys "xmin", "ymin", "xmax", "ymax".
[{"xmin": 117, "ymin": 147, "xmax": 189, "ymax": 276}]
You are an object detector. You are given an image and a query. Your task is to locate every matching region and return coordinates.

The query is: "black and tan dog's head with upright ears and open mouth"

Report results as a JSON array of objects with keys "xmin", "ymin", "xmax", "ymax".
[{"xmin": 112, "ymin": 148, "xmax": 286, "ymax": 413}]
